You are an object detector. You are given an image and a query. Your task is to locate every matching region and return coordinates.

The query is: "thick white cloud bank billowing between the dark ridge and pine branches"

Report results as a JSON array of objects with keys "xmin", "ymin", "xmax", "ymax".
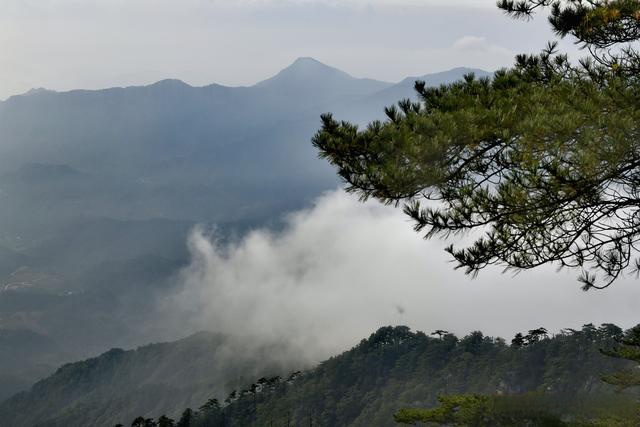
[{"xmin": 163, "ymin": 190, "xmax": 640, "ymax": 362}]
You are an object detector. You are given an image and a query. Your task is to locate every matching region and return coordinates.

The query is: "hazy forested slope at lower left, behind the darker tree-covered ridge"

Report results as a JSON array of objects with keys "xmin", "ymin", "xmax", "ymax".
[{"xmin": 0, "ymin": 332, "xmax": 300, "ymax": 427}]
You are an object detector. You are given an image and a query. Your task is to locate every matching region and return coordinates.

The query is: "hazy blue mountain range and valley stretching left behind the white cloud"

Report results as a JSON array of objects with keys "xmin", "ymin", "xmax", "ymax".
[{"xmin": 0, "ymin": 58, "xmax": 487, "ymax": 397}]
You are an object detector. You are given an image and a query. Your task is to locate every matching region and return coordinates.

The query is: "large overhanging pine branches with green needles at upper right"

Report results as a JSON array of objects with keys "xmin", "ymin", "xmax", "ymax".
[{"xmin": 313, "ymin": 0, "xmax": 640, "ymax": 290}]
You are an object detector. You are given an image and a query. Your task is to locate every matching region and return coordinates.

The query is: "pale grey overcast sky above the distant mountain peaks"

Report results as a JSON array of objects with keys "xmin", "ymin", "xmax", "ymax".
[{"xmin": 0, "ymin": 0, "xmax": 584, "ymax": 99}]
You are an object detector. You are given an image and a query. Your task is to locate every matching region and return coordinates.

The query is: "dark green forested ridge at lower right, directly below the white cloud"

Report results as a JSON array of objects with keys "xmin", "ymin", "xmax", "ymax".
[{"xmin": 127, "ymin": 325, "xmax": 634, "ymax": 427}]
